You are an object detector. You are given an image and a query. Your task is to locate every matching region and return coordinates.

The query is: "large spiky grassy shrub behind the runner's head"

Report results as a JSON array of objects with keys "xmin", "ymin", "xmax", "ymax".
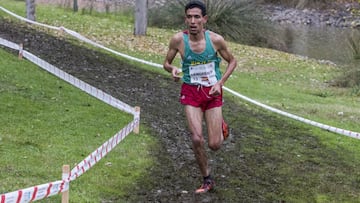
[{"xmin": 149, "ymin": 0, "xmax": 266, "ymax": 45}]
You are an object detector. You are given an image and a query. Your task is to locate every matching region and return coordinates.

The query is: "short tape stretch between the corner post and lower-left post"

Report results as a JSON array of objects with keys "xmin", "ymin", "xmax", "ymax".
[{"xmin": 68, "ymin": 119, "xmax": 139, "ymax": 181}]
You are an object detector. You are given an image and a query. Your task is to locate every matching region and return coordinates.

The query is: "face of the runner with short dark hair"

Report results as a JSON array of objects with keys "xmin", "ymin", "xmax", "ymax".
[{"xmin": 185, "ymin": 8, "xmax": 207, "ymax": 35}]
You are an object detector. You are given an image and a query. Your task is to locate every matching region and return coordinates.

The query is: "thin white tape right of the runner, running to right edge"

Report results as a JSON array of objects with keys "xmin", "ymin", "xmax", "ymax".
[{"xmin": 223, "ymin": 87, "xmax": 360, "ymax": 139}]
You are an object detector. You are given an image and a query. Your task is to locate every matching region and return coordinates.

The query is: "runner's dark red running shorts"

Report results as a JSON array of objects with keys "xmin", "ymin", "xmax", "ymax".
[{"xmin": 180, "ymin": 83, "xmax": 223, "ymax": 111}]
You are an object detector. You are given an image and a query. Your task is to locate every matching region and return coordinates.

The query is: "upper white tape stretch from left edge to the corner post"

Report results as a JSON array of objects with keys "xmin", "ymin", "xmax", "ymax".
[{"xmin": 0, "ymin": 38, "xmax": 136, "ymax": 115}]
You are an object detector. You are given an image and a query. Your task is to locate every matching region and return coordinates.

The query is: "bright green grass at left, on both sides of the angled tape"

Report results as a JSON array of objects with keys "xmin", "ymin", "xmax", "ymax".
[{"xmin": 0, "ymin": 46, "xmax": 155, "ymax": 202}]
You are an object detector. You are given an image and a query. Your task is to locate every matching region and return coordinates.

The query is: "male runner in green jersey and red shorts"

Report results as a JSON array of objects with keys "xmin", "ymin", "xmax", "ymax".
[{"xmin": 164, "ymin": 0, "xmax": 237, "ymax": 193}]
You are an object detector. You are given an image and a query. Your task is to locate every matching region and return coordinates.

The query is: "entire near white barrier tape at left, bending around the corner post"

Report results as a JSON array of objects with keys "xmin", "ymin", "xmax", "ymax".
[{"xmin": 0, "ymin": 38, "xmax": 140, "ymax": 203}]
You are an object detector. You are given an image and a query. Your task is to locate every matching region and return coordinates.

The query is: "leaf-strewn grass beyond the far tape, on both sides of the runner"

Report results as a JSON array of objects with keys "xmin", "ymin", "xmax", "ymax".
[{"xmin": 9, "ymin": 1, "xmax": 360, "ymax": 136}]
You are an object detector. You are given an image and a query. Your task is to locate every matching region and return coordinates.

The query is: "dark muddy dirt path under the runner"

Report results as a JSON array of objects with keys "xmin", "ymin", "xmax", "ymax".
[{"xmin": 0, "ymin": 18, "xmax": 318, "ymax": 202}]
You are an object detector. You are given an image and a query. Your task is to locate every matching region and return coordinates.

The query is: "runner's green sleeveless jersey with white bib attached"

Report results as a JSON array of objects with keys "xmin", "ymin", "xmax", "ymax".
[{"xmin": 182, "ymin": 30, "xmax": 221, "ymax": 87}]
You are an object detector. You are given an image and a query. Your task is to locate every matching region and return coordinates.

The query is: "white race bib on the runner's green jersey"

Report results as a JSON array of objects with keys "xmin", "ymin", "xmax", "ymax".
[{"xmin": 189, "ymin": 62, "xmax": 217, "ymax": 87}]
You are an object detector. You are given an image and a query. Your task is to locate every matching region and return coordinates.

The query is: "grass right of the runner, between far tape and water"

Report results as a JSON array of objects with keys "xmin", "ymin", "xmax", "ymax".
[{"xmin": 226, "ymin": 46, "xmax": 360, "ymax": 132}]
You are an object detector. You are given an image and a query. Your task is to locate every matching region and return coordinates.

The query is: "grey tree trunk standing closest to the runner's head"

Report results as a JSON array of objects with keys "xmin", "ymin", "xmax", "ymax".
[{"xmin": 134, "ymin": 0, "xmax": 148, "ymax": 35}]
